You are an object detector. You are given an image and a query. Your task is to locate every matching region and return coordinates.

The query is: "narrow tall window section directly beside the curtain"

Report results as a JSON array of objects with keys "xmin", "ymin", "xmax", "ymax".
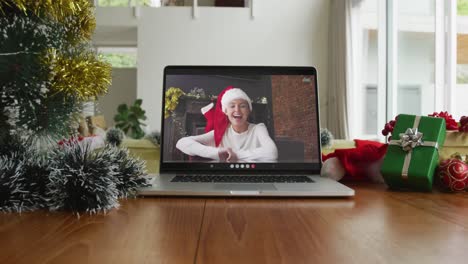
[{"xmin": 348, "ymin": 0, "xmax": 386, "ymax": 140}]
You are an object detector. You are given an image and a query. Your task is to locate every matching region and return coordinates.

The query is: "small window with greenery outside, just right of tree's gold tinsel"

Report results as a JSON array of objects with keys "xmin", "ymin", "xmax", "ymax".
[{"xmin": 97, "ymin": 47, "xmax": 137, "ymax": 68}]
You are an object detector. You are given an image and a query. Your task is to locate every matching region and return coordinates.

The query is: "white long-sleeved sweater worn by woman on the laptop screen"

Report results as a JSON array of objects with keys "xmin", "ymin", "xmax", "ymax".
[{"xmin": 176, "ymin": 123, "xmax": 278, "ymax": 162}]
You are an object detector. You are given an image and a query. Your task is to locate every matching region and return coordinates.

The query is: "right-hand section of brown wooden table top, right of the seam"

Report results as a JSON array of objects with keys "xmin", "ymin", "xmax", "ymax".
[{"xmin": 197, "ymin": 184, "xmax": 468, "ymax": 263}]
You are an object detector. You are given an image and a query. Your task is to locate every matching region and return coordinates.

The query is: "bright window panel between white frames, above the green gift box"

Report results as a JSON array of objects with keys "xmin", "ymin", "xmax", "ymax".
[{"xmin": 394, "ymin": 0, "xmax": 435, "ymax": 118}]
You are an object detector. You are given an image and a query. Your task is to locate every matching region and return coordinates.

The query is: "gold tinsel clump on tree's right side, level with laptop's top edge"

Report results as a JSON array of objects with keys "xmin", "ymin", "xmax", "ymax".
[{"xmin": 45, "ymin": 50, "xmax": 112, "ymax": 101}]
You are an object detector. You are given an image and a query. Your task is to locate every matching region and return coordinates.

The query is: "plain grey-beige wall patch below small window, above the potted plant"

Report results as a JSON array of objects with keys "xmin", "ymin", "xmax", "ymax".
[{"xmin": 98, "ymin": 68, "xmax": 137, "ymax": 127}]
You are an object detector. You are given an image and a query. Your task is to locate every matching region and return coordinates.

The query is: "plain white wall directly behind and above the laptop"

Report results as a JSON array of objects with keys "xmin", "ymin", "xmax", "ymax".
[{"xmin": 137, "ymin": 0, "xmax": 329, "ymax": 130}]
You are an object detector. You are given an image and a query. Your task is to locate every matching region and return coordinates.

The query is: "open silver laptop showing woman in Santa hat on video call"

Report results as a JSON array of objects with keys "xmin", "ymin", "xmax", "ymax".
[{"xmin": 138, "ymin": 66, "xmax": 354, "ymax": 197}]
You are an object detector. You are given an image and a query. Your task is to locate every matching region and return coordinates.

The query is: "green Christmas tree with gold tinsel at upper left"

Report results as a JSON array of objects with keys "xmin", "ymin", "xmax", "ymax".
[{"xmin": 0, "ymin": 0, "xmax": 111, "ymax": 148}]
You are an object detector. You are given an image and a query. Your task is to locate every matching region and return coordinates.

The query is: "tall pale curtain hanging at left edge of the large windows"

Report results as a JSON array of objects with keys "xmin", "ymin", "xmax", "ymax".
[{"xmin": 326, "ymin": 0, "xmax": 351, "ymax": 139}]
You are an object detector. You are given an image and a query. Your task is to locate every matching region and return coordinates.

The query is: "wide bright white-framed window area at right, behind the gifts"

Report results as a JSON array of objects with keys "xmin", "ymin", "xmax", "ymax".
[{"xmin": 348, "ymin": 0, "xmax": 468, "ymax": 140}]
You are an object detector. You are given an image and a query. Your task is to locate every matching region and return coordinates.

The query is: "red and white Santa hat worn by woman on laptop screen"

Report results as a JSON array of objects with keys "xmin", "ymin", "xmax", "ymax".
[{"xmin": 201, "ymin": 86, "xmax": 252, "ymax": 146}]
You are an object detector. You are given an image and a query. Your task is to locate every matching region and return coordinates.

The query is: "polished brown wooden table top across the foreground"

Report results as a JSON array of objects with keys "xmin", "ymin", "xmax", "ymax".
[{"xmin": 0, "ymin": 184, "xmax": 468, "ymax": 264}]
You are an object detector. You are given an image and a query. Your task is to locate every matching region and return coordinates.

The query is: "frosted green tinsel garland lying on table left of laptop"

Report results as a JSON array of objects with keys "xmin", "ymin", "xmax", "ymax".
[{"xmin": 0, "ymin": 137, "xmax": 147, "ymax": 214}]
